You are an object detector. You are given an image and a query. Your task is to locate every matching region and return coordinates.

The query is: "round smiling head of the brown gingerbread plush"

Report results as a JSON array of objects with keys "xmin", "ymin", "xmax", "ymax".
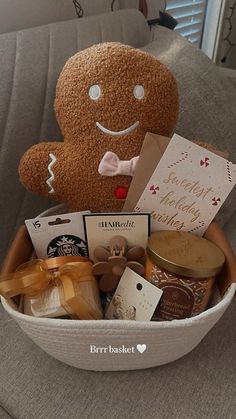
[{"xmin": 55, "ymin": 44, "xmax": 178, "ymax": 150}]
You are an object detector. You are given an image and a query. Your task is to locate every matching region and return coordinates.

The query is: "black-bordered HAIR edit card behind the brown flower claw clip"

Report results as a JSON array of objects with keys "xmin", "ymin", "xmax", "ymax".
[{"xmin": 83, "ymin": 212, "xmax": 150, "ymax": 262}]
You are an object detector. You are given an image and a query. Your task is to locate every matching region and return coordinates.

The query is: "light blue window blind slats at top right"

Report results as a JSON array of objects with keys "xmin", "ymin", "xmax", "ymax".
[{"xmin": 166, "ymin": 0, "xmax": 207, "ymax": 47}]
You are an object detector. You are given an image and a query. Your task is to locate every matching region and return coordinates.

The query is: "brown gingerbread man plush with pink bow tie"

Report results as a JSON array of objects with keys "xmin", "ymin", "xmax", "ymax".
[{"xmin": 19, "ymin": 43, "xmax": 179, "ymax": 211}]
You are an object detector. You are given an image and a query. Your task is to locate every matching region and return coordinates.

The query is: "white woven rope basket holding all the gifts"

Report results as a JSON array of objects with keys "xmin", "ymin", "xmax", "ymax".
[{"xmin": 2, "ymin": 207, "xmax": 236, "ymax": 371}]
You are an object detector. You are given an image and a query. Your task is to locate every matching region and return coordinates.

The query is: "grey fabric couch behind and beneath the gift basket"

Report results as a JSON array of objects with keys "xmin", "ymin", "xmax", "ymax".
[{"xmin": 0, "ymin": 11, "xmax": 236, "ymax": 419}]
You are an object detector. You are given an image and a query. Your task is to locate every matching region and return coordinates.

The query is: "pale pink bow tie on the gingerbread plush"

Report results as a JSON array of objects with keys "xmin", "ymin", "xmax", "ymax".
[{"xmin": 98, "ymin": 151, "xmax": 139, "ymax": 176}]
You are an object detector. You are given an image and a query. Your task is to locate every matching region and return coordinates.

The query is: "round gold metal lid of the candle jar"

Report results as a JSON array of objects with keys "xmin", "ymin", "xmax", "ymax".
[{"xmin": 147, "ymin": 231, "xmax": 225, "ymax": 278}]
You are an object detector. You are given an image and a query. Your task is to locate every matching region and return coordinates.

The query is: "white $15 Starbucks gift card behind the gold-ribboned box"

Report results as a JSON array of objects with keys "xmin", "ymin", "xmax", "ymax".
[{"xmin": 25, "ymin": 211, "xmax": 90, "ymax": 259}]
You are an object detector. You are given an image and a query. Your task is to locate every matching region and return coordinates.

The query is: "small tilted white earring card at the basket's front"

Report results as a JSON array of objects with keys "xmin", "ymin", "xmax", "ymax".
[{"xmin": 105, "ymin": 268, "xmax": 163, "ymax": 321}]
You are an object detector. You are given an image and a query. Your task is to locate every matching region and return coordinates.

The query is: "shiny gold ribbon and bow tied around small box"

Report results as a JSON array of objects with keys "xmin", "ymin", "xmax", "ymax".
[{"xmin": 0, "ymin": 259, "xmax": 102, "ymax": 320}]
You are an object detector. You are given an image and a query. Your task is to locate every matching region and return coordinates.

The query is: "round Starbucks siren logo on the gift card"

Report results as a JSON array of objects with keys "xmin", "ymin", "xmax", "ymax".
[{"xmin": 47, "ymin": 235, "xmax": 88, "ymax": 258}]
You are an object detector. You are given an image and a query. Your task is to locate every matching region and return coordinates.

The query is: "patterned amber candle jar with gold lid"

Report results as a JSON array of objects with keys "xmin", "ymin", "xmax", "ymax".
[{"xmin": 145, "ymin": 231, "xmax": 225, "ymax": 320}]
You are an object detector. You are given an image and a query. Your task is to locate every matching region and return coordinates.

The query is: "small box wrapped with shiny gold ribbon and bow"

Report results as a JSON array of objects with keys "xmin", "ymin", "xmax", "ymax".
[{"xmin": 0, "ymin": 256, "xmax": 103, "ymax": 320}]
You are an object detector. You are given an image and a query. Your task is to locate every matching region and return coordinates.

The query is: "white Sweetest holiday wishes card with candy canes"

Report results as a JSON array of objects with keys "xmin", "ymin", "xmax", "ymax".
[{"xmin": 135, "ymin": 134, "xmax": 236, "ymax": 235}]
